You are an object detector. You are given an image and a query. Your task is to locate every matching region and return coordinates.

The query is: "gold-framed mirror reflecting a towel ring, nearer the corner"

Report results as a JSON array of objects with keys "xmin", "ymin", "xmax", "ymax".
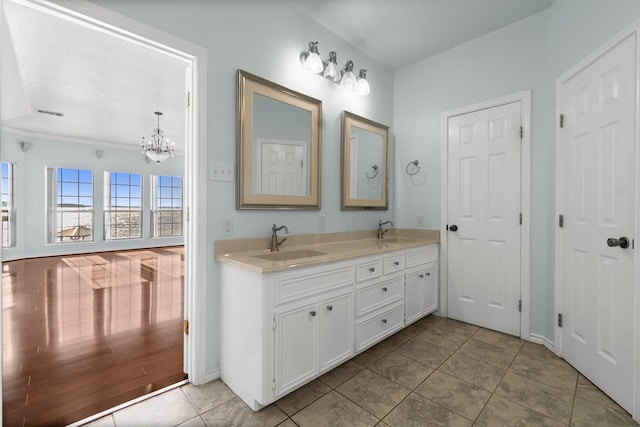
[{"xmin": 342, "ymin": 111, "xmax": 389, "ymax": 209}]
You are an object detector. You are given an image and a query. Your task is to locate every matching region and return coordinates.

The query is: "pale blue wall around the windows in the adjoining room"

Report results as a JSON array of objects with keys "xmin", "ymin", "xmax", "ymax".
[{"xmin": 0, "ymin": 131, "xmax": 184, "ymax": 261}]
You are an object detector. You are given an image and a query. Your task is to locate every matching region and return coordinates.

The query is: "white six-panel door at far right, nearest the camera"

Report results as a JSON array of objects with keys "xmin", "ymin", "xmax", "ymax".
[{"xmin": 557, "ymin": 36, "xmax": 637, "ymax": 412}]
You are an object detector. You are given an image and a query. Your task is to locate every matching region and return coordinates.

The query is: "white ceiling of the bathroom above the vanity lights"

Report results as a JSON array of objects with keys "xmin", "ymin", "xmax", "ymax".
[{"xmin": 289, "ymin": 0, "xmax": 554, "ymax": 70}]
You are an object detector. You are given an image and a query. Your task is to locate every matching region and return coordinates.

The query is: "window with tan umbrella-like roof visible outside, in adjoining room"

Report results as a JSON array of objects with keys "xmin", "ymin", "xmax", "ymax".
[{"xmin": 47, "ymin": 168, "xmax": 93, "ymax": 243}]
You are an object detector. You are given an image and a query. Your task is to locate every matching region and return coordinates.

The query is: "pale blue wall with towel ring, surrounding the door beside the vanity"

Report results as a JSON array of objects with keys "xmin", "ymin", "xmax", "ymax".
[{"xmin": 394, "ymin": 0, "xmax": 640, "ymax": 341}]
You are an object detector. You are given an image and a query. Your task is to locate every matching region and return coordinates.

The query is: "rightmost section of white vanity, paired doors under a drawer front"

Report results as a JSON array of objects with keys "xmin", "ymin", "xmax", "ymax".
[{"xmin": 404, "ymin": 245, "xmax": 439, "ymax": 325}]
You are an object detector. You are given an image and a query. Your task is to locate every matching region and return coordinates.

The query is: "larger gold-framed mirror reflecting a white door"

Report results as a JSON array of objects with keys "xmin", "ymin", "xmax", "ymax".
[{"xmin": 238, "ymin": 70, "xmax": 322, "ymax": 209}]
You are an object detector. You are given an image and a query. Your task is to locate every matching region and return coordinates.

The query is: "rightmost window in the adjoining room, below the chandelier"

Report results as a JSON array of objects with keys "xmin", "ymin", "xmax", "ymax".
[{"xmin": 151, "ymin": 175, "xmax": 182, "ymax": 237}]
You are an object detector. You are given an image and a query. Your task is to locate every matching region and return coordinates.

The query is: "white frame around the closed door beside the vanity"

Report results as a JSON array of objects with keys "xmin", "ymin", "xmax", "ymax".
[{"xmin": 439, "ymin": 90, "xmax": 528, "ymax": 341}]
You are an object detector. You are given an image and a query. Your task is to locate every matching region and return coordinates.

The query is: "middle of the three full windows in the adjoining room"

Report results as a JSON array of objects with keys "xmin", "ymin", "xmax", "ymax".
[{"xmin": 104, "ymin": 172, "xmax": 142, "ymax": 240}]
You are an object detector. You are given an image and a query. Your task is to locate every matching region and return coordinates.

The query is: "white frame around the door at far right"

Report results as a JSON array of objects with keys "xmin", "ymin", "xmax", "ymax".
[{"xmin": 553, "ymin": 20, "xmax": 640, "ymax": 421}]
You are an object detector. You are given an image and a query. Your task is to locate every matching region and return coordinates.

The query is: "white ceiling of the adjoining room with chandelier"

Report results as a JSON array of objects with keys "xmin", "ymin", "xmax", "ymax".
[{"xmin": 1, "ymin": 1, "xmax": 187, "ymax": 151}]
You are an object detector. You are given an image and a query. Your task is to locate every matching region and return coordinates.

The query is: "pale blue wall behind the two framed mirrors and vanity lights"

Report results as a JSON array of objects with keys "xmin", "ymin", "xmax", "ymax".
[{"xmin": 89, "ymin": 0, "xmax": 393, "ymax": 378}]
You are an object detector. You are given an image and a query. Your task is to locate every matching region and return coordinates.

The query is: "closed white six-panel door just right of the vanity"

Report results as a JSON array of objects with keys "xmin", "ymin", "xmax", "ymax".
[{"xmin": 447, "ymin": 101, "xmax": 522, "ymax": 336}]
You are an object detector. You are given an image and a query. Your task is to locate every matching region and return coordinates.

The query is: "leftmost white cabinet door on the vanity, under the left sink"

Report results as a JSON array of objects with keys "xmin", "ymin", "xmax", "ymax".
[{"xmin": 275, "ymin": 303, "xmax": 320, "ymax": 396}]
